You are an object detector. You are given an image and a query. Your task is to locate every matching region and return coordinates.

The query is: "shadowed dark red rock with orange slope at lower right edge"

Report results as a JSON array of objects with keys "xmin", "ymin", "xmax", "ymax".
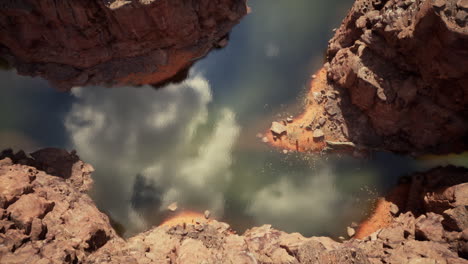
[{"xmin": 355, "ymin": 166, "xmax": 468, "ymax": 239}]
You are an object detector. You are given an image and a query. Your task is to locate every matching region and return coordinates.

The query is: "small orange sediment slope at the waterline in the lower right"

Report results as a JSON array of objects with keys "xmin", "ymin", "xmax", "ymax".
[{"xmin": 354, "ymin": 184, "xmax": 409, "ymax": 239}]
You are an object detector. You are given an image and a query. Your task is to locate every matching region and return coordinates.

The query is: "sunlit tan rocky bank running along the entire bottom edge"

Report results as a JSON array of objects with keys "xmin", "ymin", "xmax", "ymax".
[{"xmin": 0, "ymin": 149, "xmax": 468, "ymax": 264}]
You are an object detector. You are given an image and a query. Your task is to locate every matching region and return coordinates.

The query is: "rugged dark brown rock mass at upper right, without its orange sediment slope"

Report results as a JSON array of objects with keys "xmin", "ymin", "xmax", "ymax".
[{"xmin": 327, "ymin": 0, "xmax": 468, "ymax": 152}]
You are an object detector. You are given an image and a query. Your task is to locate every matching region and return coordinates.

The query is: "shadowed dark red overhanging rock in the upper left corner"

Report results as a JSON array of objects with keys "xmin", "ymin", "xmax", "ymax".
[{"xmin": 0, "ymin": 0, "xmax": 247, "ymax": 90}]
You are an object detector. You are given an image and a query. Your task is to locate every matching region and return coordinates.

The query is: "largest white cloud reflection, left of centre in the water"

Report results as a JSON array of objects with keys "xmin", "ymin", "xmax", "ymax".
[{"xmin": 65, "ymin": 75, "xmax": 240, "ymax": 232}]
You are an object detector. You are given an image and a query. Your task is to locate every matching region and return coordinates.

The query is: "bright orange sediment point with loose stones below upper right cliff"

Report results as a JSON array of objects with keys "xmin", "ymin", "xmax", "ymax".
[{"xmin": 265, "ymin": 68, "xmax": 338, "ymax": 152}]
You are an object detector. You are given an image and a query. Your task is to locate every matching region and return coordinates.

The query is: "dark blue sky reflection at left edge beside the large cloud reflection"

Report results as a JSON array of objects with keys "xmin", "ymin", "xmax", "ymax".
[{"xmin": 0, "ymin": 71, "xmax": 73, "ymax": 151}]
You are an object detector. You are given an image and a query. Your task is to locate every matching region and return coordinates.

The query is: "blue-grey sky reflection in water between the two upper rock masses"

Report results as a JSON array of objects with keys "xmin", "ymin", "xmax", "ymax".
[{"xmin": 196, "ymin": 0, "xmax": 352, "ymax": 120}]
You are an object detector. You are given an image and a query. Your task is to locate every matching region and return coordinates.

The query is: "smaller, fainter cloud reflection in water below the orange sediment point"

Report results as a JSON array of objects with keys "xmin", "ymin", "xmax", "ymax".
[{"xmin": 248, "ymin": 167, "xmax": 343, "ymax": 233}]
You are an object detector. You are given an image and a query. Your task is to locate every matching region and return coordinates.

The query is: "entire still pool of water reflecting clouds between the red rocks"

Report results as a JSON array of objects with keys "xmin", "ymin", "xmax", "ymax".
[{"xmin": 0, "ymin": 0, "xmax": 468, "ymax": 239}]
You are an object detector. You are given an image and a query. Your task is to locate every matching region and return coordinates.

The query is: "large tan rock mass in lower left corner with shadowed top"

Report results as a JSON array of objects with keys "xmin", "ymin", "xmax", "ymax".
[{"xmin": 0, "ymin": 149, "xmax": 119, "ymax": 263}]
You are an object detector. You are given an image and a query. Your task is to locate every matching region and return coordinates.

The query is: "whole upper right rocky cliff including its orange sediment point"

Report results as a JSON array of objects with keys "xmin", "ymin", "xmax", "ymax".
[{"xmin": 270, "ymin": 0, "xmax": 468, "ymax": 154}]
